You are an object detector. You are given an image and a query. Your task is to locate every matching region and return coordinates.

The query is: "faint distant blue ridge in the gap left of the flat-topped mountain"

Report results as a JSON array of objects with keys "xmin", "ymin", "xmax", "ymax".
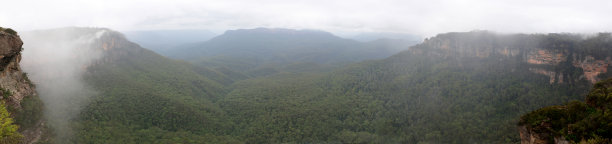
[{"xmin": 122, "ymin": 30, "xmax": 218, "ymax": 55}]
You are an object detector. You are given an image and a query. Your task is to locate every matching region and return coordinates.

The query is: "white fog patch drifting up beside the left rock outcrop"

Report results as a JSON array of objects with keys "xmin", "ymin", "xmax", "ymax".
[{"xmin": 21, "ymin": 28, "xmax": 105, "ymax": 143}]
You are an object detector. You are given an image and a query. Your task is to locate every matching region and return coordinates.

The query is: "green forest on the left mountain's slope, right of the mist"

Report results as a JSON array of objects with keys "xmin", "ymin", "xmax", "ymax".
[{"xmin": 73, "ymin": 36, "xmax": 241, "ymax": 143}]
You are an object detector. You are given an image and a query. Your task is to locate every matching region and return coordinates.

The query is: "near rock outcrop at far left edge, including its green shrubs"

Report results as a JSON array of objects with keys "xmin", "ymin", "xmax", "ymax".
[{"xmin": 0, "ymin": 27, "xmax": 44, "ymax": 143}]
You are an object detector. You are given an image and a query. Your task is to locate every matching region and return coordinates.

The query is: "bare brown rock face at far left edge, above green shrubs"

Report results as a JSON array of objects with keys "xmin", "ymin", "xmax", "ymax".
[{"xmin": 0, "ymin": 32, "xmax": 36, "ymax": 108}]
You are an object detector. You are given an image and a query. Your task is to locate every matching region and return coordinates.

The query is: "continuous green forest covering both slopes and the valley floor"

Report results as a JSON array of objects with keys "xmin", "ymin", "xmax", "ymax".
[{"xmin": 19, "ymin": 28, "xmax": 612, "ymax": 143}]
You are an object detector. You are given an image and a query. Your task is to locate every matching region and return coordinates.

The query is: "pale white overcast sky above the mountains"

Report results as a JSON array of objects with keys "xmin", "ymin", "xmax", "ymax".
[{"xmin": 0, "ymin": 0, "xmax": 612, "ymax": 36}]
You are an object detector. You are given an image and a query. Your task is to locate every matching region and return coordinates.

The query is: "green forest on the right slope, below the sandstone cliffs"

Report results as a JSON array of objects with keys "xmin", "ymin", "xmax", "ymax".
[{"xmin": 220, "ymin": 49, "xmax": 582, "ymax": 143}]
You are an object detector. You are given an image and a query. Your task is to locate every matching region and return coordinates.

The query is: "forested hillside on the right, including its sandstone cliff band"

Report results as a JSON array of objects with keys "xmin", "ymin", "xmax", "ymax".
[{"xmin": 219, "ymin": 31, "xmax": 612, "ymax": 143}]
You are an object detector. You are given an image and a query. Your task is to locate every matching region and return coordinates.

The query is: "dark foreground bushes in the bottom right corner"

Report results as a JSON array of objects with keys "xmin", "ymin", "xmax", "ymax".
[{"xmin": 519, "ymin": 79, "xmax": 612, "ymax": 144}]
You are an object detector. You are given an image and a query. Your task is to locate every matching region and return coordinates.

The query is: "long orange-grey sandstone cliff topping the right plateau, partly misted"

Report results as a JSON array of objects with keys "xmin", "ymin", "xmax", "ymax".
[{"xmin": 410, "ymin": 31, "xmax": 612, "ymax": 84}]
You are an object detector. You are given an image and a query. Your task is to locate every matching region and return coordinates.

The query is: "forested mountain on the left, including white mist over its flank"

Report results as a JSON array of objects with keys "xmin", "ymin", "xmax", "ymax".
[{"xmin": 23, "ymin": 28, "xmax": 239, "ymax": 143}]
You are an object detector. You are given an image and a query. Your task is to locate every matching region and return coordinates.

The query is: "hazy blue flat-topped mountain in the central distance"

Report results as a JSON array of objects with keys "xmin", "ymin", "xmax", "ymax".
[{"xmin": 168, "ymin": 28, "xmax": 414, "ymax": 76}]
